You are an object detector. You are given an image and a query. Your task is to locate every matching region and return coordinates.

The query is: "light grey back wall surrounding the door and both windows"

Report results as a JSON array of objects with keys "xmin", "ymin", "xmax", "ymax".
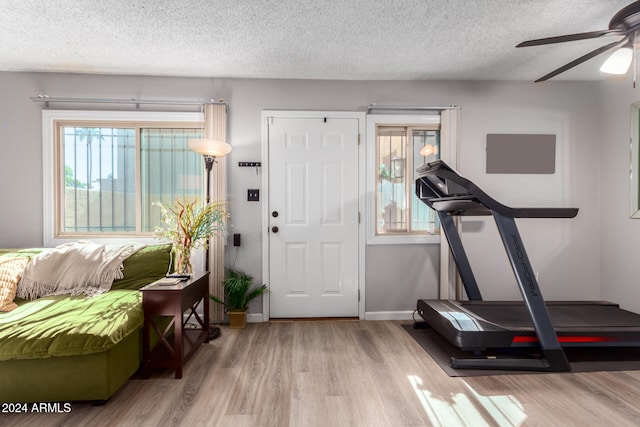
[{"xmin": 0, "ymin": 73, "xmax": 604, "ymax": 313}]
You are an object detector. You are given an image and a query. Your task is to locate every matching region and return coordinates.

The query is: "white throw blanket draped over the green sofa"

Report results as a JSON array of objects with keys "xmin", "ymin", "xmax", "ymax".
[{"xmin": 16, "ymin": 242, "xmax": 145, "ymax": 299}]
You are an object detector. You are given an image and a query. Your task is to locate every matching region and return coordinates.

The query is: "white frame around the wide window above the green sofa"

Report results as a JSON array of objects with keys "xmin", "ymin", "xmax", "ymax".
[{"xmin": 42, "ymin": 110, "xmax": 204, "ymax": 247}]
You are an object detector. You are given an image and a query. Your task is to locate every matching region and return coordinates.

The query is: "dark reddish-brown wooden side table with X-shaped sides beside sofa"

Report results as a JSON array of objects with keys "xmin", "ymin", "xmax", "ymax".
[{"xmin": 140, "ymin": 272, "xmax": 209, "ymax": 378}]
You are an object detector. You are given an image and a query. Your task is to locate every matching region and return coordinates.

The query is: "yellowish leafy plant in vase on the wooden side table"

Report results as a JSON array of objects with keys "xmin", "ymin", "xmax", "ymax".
[{"xmin": 154, "ymin": 198, "xmax": 229, "ymax": 275}]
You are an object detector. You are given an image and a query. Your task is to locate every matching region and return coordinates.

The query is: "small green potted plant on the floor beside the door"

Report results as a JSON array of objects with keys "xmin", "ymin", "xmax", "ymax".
[{"xmin": 209, "ymin": 269, "xmax": 269, "ymax": 329}]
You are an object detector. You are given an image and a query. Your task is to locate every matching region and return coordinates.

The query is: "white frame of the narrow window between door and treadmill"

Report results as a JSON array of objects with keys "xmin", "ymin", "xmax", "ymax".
[{"xmin": 367, "ymin": 111, "xmax": 450, "ymax": 245}]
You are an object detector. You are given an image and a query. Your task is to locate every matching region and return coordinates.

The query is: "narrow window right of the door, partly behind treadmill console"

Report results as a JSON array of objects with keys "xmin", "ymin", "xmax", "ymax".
[{"xmin": 367, "ymin": 112, "xmax": 457, "ymax": 244}]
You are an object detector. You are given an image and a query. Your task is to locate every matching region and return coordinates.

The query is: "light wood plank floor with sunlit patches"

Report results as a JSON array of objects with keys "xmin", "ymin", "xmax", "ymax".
[{"xmin": 0, "ymin": 321, "xmax": 640, "ymax": 427}]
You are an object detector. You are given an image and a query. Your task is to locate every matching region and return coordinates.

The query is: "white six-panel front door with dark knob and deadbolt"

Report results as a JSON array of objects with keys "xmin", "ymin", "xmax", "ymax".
[{"xmin": 268, "ymin": 116, "xmax": 359, "ymax": 318}]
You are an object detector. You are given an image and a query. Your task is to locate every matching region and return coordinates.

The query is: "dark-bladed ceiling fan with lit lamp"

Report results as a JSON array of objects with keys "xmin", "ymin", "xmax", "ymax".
[{"xmin": 516, "ymin": 1, "xmax": 640, "ymax": 82}]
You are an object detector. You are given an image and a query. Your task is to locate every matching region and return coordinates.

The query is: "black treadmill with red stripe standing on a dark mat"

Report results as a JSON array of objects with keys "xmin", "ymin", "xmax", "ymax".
[{"xmin": 414, "ymin": 160, "xmax": 640, "ymax": 372}]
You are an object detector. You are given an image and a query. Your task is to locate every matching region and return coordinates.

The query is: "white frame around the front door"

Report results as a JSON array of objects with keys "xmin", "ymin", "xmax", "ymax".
[{"xmin": 262, "ymin": 110, "xmax": 367, "ymax": 322}]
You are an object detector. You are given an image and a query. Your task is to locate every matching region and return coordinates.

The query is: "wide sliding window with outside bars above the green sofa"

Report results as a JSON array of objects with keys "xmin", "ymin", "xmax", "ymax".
[{"xmin": 43, "ymin": 111, "xmax": 204, "ymax": 243}]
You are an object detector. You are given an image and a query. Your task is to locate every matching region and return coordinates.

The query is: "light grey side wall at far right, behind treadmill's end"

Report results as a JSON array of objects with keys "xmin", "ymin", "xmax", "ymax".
[{"xmin": 599, "ymin": 73, "xmax": 640, "ymax": 313}]
